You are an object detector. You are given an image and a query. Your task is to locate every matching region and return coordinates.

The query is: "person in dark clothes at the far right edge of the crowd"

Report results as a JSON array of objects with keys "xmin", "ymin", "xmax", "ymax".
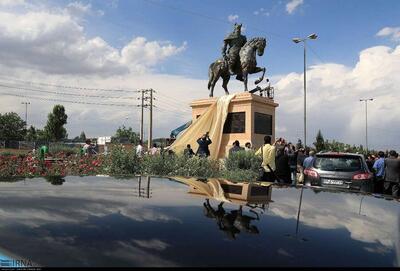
[{"xmin": 383, "ymin": 150, "xmax": 400, "ymax": 197}]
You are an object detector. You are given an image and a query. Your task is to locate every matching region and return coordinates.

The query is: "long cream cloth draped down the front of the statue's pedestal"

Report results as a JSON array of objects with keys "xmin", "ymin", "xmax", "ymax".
[{"xmin": 170, "ymin": 94, "xmax": 235, "ymax": 159}]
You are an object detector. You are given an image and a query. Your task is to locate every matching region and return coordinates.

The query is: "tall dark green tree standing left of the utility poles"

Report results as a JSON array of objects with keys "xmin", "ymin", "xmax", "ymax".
[{"xmin": 44, "ymin": 104, "xmax": 68, "ymax": 141}]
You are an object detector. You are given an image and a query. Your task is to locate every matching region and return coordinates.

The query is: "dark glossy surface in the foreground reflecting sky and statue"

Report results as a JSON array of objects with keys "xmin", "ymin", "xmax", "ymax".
[{"xmin": 0, "ymin": 177, "xmax": 400, "ymax": 267}]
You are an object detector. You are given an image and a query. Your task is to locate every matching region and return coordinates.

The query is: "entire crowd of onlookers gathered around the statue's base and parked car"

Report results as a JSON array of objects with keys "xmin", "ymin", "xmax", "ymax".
[{"xmin": 94, "ymin": 132, "xmax": 400, "ymax": 196}]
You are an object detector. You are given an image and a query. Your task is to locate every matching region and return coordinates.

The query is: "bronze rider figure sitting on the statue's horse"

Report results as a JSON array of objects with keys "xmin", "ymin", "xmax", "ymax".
[{"xmin": 222, "ymin": 23, "xmax": 247, "ymax": 80}]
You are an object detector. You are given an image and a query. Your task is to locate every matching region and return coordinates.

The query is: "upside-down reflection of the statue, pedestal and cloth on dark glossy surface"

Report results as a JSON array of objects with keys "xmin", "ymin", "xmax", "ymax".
[{"xmin": 174, "ymin": 178, "xmax": 272, "ymax": 239}]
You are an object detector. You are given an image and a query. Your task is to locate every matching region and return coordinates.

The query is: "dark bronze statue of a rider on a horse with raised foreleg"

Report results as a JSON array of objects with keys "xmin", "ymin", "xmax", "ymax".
[{"xmin": 208, "ymin": 23, "xmax": 267, "ymax": 97}]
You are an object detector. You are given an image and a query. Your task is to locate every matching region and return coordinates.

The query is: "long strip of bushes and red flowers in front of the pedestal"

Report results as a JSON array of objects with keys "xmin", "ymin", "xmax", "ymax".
[{"xmin": 0, "ymin": 142, "xmax": 261, "ymax": 184}]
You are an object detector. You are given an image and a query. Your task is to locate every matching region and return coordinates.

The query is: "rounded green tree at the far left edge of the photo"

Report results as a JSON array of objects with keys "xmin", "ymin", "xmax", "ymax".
[{"xmin": 0, "ymin": 112, "xmax": 26, "ymax": 140}]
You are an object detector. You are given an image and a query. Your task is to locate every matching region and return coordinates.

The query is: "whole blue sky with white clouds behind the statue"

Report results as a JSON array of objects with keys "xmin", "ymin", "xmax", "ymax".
[{"xmin": 0, "ymin": 0, "xmax": 400, "ymax": 150}]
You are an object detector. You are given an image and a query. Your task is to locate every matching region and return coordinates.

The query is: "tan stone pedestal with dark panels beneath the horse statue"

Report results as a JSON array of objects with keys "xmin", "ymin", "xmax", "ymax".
[{"xmin": 190, "ymin": 92, "xmax": 279, "ymax": 158}]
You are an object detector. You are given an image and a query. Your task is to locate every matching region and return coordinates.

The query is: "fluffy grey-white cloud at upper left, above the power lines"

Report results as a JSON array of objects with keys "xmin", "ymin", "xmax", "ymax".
[{"xmin": 0, "ymin": 8, "xmax": 186, "ymax": 75}]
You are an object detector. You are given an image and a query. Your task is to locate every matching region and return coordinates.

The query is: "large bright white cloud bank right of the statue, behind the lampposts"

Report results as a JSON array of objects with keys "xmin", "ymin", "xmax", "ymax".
[{"xmin": 275, "ymin": 46, "xmax": 400, "ymax": 149}]
